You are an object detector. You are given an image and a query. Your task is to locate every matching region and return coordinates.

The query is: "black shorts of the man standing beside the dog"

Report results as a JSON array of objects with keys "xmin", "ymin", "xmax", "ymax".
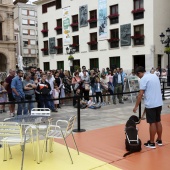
[{"xmin": 146, "ymin": 106, "xmax": 162, "ymax": 123}]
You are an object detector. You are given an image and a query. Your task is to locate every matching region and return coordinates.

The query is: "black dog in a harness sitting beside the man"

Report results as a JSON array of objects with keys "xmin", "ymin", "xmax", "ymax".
[{"xmin": 123, "ymin": 119, "xmax": 142, "ymax": 157}]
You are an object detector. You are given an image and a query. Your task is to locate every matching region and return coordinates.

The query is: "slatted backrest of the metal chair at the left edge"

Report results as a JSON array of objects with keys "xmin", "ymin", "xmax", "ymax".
[{"xmin": 0, "ymin": 122, "xmax": 22, "ymax": 139}]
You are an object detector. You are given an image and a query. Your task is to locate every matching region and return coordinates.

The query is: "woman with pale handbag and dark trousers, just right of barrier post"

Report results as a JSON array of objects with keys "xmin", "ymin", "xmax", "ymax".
[{"xmin": 81, "ymin": 71, "xmax": 90, "ymax": 101}]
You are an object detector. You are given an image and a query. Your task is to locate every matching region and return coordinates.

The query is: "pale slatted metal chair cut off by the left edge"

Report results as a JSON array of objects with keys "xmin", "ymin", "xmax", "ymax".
[{"xmin": 0, "ymin": 122, "xmax": 34, "ymax": 161}]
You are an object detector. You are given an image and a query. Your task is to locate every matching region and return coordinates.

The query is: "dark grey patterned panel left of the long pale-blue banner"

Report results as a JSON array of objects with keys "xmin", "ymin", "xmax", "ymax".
[{"xmin": 79, "ymin": 5, "xmax": 88, "ymax": 27}]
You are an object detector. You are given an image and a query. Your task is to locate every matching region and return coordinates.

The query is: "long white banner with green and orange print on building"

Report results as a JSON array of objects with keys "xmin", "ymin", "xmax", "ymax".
[{"xmin": 63, "ymin": 7, "xmax": 71, "ymax": 45}]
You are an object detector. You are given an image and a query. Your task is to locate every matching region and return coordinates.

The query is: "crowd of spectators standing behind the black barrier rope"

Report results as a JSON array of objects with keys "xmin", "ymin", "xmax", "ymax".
[{"xmin": 0, "ymin": 66, "xmax": 166, "ymax": 116}]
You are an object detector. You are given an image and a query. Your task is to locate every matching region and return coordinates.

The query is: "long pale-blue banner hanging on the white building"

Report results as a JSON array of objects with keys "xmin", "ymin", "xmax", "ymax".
[{"xmin": 98, "ymin": 0, "xmax": 107, "ymax": 40}]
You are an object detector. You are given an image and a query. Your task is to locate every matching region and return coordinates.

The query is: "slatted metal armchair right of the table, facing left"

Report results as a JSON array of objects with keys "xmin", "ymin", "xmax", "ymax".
[{"xmin": 41, "ymin": 116, "xmax": 79, "ymax": 164}]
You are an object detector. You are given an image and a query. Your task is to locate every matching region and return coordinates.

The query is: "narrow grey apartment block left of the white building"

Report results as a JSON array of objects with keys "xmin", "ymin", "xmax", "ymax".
[{"xmin": 14, "ymin": 0, "xmax": 39, "ymax": 67}]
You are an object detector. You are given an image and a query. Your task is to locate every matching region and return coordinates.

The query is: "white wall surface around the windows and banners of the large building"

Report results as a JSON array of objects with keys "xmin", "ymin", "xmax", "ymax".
[{"xmin": 35, "ymin": 0, "xmax": 168, "ymax": 70}]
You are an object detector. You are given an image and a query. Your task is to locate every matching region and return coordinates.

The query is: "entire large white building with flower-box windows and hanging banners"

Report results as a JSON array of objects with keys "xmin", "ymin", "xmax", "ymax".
[{"xmin": 34, "ymin": 0, "xmax": 170, "ymax": 70}]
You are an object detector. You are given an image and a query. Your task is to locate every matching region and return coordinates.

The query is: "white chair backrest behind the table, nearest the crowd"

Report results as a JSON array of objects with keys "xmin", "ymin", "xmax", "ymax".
[{"xmin": 31, "ymin": 108, "xmax": 51, "ymax": 116}]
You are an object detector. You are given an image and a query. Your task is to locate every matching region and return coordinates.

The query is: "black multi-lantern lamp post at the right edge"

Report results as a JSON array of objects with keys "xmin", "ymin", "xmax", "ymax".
[{"xmin": 160, "ymin": 28, "xmax": 170, "ymax": 86}]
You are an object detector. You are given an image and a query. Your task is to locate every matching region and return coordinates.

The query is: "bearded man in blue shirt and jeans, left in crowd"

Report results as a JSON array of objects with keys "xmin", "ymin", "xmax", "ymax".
[{"xmin": 11, "ymin": 70, "xmax": 27, "ymax": 115}]
